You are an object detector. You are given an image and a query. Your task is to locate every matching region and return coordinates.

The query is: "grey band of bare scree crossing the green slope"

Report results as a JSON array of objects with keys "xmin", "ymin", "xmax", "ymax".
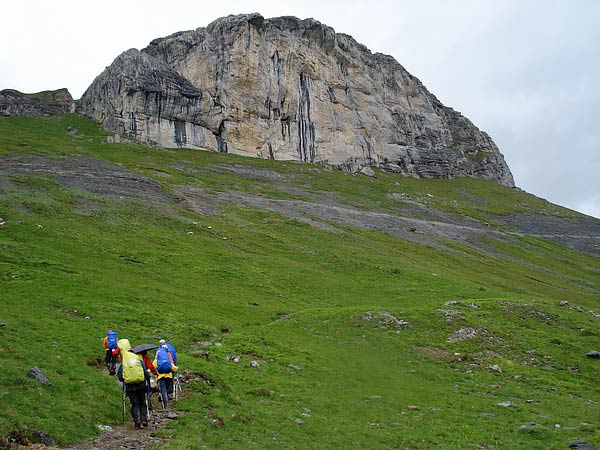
[{"xmin": 0, "ymin": 154, "xmax": 600, "ymax": 255}]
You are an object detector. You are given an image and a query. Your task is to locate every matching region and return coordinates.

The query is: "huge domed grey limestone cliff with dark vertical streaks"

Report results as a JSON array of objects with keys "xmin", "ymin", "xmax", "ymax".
[{"xmin": 80, "ymin": 14, "xmax": 514, "ymax": 186}]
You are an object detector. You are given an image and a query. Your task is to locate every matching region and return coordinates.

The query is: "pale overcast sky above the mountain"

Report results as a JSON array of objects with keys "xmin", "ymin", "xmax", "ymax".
[{"xmin": 0, "ymin": 0, "xmax": 600, "ymax": 218}]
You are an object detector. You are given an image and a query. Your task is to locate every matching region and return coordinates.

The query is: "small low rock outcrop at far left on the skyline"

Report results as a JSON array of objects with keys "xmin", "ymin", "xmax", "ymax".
[{"xmin": 0, "ymin": 89, "xmax": 75, "ymax": 116}]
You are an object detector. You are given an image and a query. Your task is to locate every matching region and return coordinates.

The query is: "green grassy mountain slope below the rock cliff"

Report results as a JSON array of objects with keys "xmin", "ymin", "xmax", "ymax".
[{"xmin": 0, "ymin": 116, "xmax": 600, "ymax": 449}]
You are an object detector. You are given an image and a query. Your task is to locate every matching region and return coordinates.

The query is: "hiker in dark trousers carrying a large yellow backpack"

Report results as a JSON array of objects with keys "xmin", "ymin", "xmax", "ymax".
[{"xmin": 117, "ymin": 339, "xmax": 150, "ymax": 429}]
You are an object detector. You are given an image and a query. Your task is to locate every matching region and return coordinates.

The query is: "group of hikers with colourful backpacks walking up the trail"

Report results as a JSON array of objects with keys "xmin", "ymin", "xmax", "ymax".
[{"xmin": 103, "ymin": 330, "xmax": 178, "ymax": 429}]
